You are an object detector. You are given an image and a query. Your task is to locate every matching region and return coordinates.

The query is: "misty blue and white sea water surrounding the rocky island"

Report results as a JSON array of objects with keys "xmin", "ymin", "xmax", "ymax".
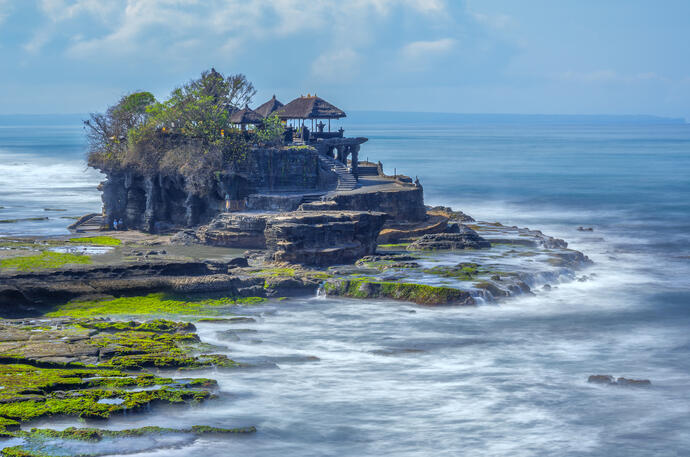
[{"xmin": 0, "ymin": 114, "xmax": 690, "ymax": 456}]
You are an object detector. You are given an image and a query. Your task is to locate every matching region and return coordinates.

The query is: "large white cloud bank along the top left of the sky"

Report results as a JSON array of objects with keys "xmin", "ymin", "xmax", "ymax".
[{"xmin": 22, "ymin": 0, "xmax": 446, "ymax": 58}]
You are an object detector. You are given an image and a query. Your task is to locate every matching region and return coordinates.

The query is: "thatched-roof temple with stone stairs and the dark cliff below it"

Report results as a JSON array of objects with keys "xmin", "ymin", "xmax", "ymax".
[{"xmin": 94, "ymin": 95, "xmax": 426, "ymax": 233}]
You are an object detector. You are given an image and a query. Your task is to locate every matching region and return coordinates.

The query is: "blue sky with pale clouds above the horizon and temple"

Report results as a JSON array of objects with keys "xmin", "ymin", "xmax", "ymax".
[{"xmin": 0, "ymin": 0, "xmax": 690, "ymax": 119}]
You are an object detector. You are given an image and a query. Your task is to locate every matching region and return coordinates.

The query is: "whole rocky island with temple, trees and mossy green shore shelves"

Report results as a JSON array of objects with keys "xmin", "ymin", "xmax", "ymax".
[{"xmin": 0, "ymin": 69, "xmax": 589, "ymax": 455}]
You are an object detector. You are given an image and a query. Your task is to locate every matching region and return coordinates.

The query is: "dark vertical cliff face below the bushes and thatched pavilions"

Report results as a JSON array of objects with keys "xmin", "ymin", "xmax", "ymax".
[{"xmin": 101, "ymin": 148, "xmax": 337, "ymax": 232}]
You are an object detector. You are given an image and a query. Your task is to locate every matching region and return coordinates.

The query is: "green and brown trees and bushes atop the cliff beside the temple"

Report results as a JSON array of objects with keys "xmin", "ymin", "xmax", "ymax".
[{"xmin": 85, "ymin": 69, "xmax": 283, "ymax": 195}]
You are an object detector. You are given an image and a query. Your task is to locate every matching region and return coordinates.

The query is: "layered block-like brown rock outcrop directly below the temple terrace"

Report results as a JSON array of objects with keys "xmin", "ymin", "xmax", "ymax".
[{"xmin": 196, "ymin": 211, "xmax": 387, "ymax": 265}]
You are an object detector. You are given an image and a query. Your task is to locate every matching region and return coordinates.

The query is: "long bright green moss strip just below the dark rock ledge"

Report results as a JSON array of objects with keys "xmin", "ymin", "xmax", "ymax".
[{"xmin": 47, "ymin": 293, "xmax": 265, "ymax": 317}]
